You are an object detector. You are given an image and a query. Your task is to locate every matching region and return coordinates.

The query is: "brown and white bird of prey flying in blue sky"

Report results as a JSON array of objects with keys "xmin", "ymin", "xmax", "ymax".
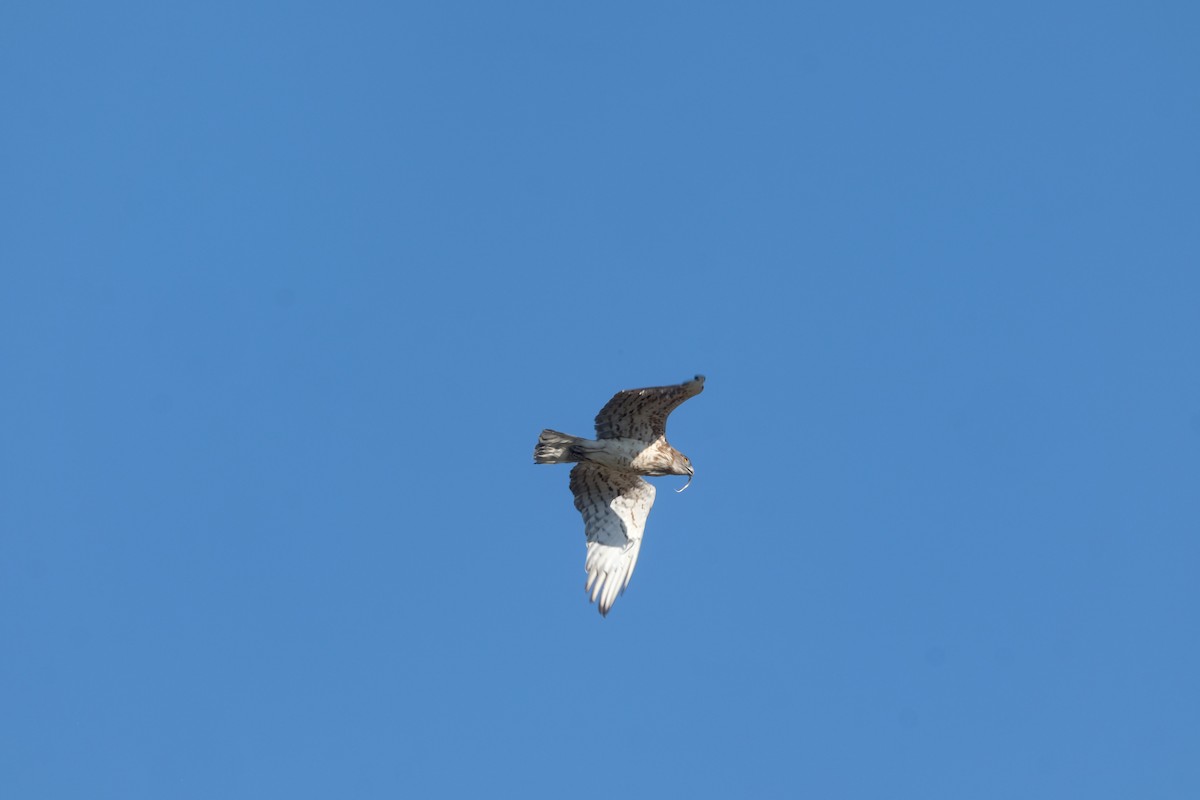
[{"xmin": 533, "ymin": 375, "xmax": 704, "ymax": 616}]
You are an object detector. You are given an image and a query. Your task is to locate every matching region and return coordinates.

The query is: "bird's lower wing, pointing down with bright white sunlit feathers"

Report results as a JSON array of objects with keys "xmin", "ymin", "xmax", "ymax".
[{"xmin": 571, "ymin": 462, "xmax": 654, "ymax": 616}]
